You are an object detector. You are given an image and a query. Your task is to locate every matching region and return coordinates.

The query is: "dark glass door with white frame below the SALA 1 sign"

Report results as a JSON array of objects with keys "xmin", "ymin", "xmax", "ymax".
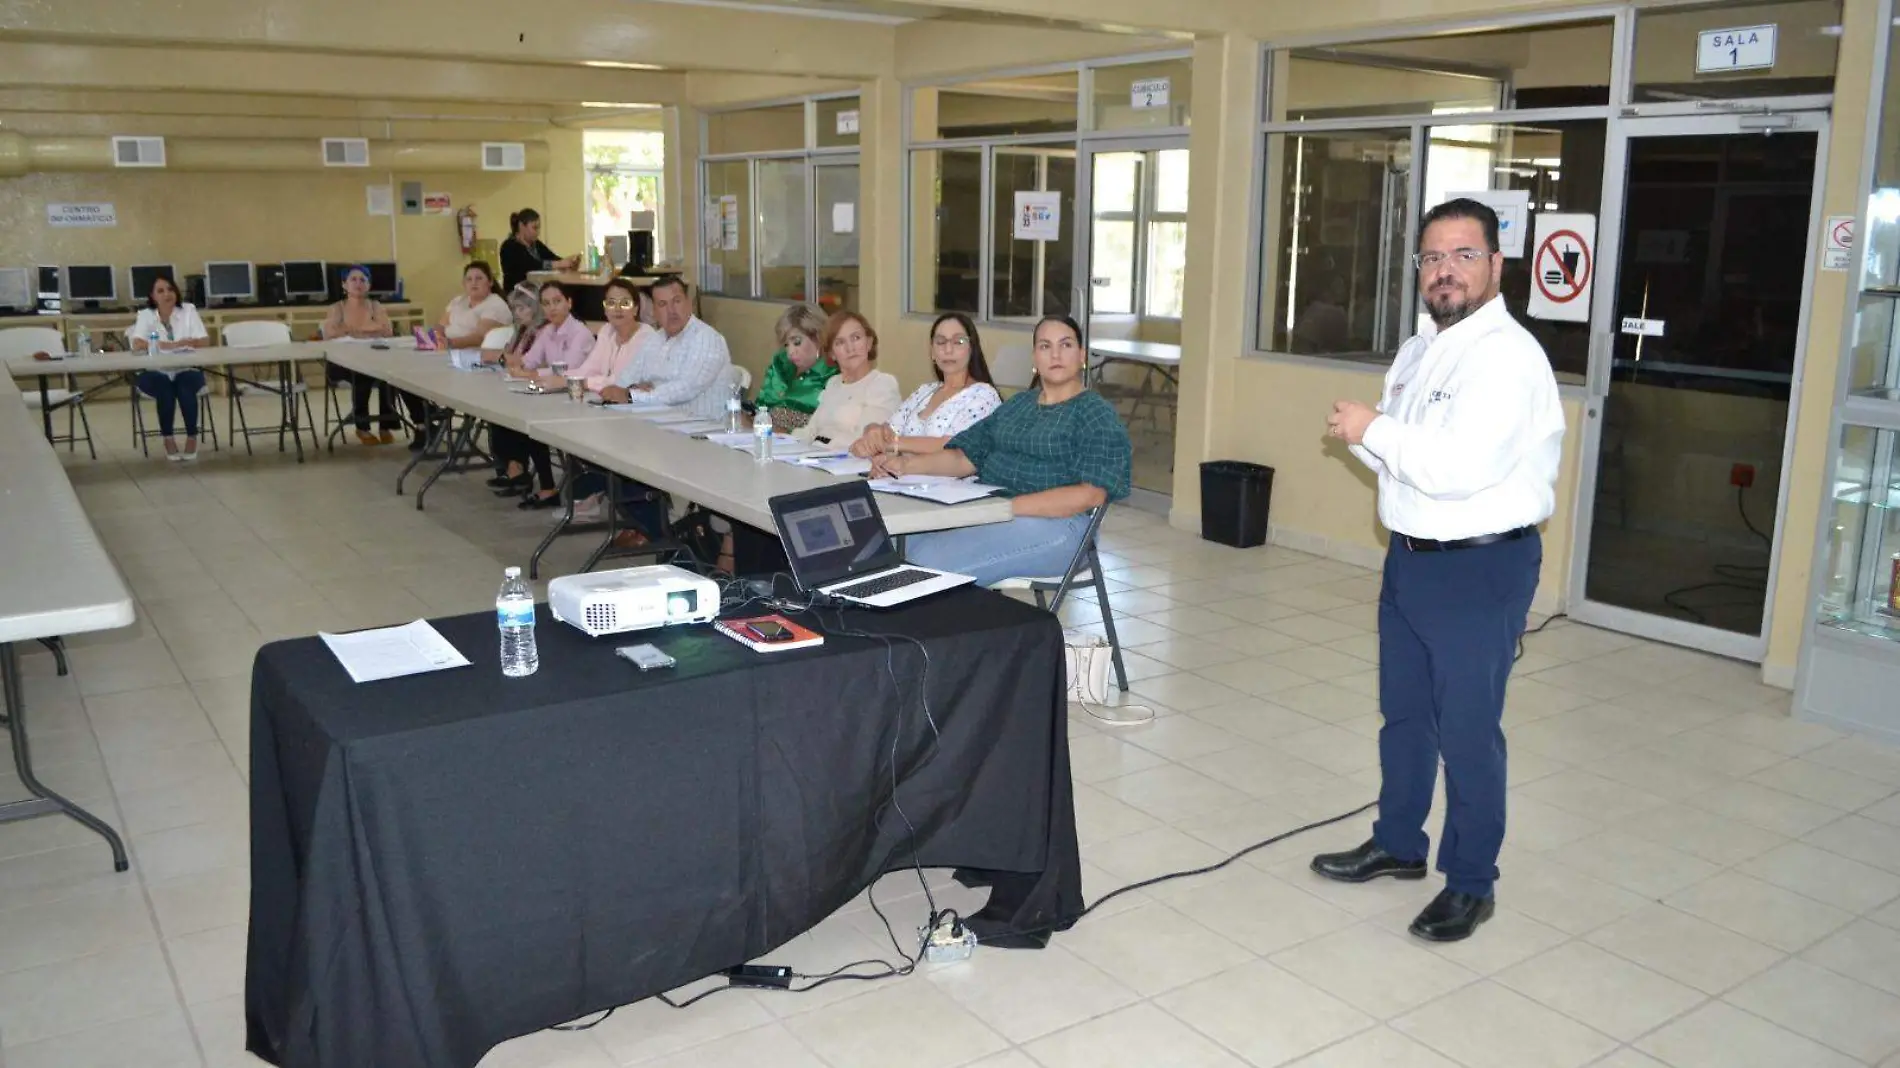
[{"xmin": 1571, "ymin": 114, "xmax": 1826, "ymax": 659}]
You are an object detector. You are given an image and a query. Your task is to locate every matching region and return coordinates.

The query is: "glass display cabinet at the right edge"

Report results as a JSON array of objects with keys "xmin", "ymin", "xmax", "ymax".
[{"xmin": 1796, "ymin": 10, "xmax": 1900, "ymax": 741}]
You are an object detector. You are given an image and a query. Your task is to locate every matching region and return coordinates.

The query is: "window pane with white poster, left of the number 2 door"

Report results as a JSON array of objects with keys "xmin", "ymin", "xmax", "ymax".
[{"xmin": 990, "ymin": 148, "xmax": 1075, "ymax": 319}]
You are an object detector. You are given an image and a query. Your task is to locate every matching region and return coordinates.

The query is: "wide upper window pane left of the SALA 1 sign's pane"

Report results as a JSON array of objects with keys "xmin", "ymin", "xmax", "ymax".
[{"xmin": 1269, "ymin": 19, "xmax": 1611, "ymax": 122}]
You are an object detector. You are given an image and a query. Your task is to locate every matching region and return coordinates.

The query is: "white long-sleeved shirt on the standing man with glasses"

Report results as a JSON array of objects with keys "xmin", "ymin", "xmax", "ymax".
[{"xmin": 1353, "ymin": 296, "xmax": 1564, "ymax": 542}]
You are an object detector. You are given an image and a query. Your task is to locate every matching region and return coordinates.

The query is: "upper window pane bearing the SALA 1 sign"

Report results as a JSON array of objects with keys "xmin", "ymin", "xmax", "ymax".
[{"xmin": 1630, "ymin": 0, "xmax": 1841, "ymax": 103}]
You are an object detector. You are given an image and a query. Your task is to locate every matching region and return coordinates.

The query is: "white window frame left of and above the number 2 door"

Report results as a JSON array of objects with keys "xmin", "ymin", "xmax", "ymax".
[{"xmin": 901, "ymin": 49, "xmax": 1193, "ymax": 325}]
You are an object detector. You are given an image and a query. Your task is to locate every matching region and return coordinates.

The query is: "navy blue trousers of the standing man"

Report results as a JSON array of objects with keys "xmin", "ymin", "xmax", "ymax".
[{"xmin": 1372, "ymin": 534, "xmax": 1543, "ymax": 897}]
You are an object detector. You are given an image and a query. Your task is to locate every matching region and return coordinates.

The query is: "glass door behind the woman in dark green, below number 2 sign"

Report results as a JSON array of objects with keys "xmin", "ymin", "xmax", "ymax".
[{"xmin": 1075, "ymin": 137, "xmax": 1188, "ymax": 496}]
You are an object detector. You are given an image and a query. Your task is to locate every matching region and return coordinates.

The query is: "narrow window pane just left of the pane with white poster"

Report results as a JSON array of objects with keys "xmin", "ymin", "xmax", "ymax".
[{"xmin": 910, "ymin": 148, "xmax": 982, "ymax": 315}]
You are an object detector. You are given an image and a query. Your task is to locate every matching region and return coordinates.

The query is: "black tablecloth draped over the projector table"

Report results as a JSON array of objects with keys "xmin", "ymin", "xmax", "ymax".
[{"xmin": 245, "ymin": 589, "xmax": 1081, "ymax": 1068}]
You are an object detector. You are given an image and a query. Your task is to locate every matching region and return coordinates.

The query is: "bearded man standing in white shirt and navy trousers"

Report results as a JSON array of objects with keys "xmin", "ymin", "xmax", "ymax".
[{"xmin": 1313, "ymin": 198, "xmax": 1564, "ymax": 943}]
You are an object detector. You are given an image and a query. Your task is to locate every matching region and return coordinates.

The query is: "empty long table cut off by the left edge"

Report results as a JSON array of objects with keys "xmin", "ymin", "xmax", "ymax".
[{"xmin": 0, "ymin": 364, "xmax": 133, "ymax": 870}]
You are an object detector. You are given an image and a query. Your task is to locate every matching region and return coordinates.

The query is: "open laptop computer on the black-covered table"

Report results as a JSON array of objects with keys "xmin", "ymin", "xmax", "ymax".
[{"xmin": 768, "ymin": 479, "xmax": 975, "ymax": 608}]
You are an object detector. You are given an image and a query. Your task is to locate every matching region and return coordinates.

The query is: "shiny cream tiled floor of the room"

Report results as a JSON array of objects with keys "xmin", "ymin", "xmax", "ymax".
[{"xmin": 0, "ymin": 395, "xmax": 1900, "ymax": 1068}]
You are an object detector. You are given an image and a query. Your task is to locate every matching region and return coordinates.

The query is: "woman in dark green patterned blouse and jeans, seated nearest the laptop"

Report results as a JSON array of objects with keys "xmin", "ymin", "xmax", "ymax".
[{"xmin": 872, "ymin": 315, "xmax": 1134, "ymax": 585}]
